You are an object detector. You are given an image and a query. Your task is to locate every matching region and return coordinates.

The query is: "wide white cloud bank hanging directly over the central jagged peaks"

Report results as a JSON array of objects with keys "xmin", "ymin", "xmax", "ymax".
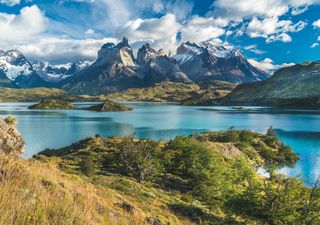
[{"xmin": 117, "ymin": 14, "xmax": 229, "ymax": 52}]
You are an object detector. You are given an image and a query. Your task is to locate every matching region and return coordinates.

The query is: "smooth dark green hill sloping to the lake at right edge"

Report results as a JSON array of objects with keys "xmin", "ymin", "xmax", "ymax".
[{"xmin": 222, "ymin": 62, "xmax": 320, "ymax": 107}]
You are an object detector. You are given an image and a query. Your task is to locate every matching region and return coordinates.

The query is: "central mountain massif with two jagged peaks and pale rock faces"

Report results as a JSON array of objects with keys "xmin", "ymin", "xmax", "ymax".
[{"xmin": 63, "ymin": 38, "xmax": 192, "ymax": 94}]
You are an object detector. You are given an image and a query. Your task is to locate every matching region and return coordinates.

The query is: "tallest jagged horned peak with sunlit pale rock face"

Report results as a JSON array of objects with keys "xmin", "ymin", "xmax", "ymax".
[{"xmin": 62, "ymin": 38, "xmax": 141, "ymax": 94}]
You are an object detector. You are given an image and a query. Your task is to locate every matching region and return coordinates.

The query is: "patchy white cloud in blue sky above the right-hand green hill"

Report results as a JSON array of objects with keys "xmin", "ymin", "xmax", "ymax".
[{"xmin": 246, "ymin": 17, "xmax": 307, "ymax": 43}]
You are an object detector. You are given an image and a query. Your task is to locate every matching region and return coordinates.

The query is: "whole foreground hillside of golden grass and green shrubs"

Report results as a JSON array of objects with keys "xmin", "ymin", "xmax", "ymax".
[{"xmin": 0, "ymin": 130, "xmax": 320, "ymax": 225}]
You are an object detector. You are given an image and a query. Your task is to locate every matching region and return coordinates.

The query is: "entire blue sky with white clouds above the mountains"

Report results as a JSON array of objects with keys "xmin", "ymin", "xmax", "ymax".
[{"xmin": 0, "ymin": 0, "xmax": 320, "ymax": 71}]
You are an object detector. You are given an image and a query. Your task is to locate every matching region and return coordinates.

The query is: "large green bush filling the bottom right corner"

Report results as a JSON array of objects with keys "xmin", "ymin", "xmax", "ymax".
[{"xmin": 227, "ymin": 176, "xmax": 320, "ymax": 225}]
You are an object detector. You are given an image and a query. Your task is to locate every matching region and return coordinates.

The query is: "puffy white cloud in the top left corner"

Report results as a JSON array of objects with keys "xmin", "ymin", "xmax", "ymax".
[{"xmin": 0, "ymin": 5, "xmax": 47, "ymax": 45}]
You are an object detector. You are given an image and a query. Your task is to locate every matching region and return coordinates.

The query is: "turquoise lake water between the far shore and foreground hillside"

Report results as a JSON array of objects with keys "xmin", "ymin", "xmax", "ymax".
[{"xmin": 0, "ymin": 103, "xmax": 320, "ymax": 184}]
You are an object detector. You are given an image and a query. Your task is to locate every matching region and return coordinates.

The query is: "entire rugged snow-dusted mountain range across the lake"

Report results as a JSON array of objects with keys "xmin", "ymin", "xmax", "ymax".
[{"xmin": 0, "ymin": 38, "xmax": 269, "ymax": 95}]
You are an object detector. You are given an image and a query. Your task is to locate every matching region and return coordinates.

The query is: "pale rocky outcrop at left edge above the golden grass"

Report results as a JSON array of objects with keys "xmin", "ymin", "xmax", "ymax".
[{"xmin": 0, "ymin": 119, "xmax": 25, "ymax": 154}]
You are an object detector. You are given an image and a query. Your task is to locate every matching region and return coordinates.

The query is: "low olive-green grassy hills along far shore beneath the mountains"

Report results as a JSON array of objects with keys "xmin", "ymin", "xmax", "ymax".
[{"xmin": 0, "ymin": 81, "xmax": 235, "ymax": 105}]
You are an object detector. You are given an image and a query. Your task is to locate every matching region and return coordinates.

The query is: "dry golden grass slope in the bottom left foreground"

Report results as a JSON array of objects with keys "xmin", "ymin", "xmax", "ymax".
[{"xmin": 0, "ymin": 153, "xmax": 191, "ymax": 225}]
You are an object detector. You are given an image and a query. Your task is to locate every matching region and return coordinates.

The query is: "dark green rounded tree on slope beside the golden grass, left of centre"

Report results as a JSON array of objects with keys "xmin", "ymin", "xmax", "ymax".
[{"xmin": 119, "ymin": 137, "xmax": 161, "ymax": 183}]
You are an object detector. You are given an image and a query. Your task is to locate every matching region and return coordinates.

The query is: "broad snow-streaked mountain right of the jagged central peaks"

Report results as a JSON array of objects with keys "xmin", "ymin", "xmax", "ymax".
[{"xmin": 175, "ymin": 42, "xmax": 269, "ymax": 83}]
